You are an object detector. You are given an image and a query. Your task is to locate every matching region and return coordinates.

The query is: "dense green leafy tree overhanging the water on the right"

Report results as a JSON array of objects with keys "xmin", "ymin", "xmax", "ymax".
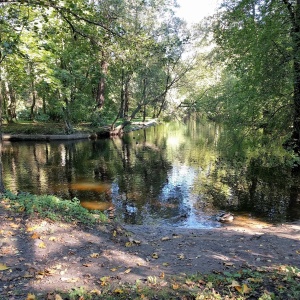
[{"xmin": 200, "ymin": 0, "xmax": 300, "ymax": 152}]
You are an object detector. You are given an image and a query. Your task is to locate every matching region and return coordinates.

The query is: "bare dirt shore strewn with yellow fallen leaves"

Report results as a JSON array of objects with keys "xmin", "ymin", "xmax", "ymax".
[{"xmin": 0, "ymin": 207, "xmax": 300, "ymax": 299}]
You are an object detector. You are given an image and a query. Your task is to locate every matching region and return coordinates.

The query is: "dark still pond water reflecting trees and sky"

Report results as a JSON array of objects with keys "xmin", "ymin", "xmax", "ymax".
[{"xmin": 2, "ymin": 120, "xmax": 300, "ymax": 228}]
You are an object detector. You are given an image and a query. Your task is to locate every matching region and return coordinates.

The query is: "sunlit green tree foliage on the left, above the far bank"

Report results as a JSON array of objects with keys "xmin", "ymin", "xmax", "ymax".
[{"xmin": 0, "ymin": 0, "xmax": 187, "ymax": 125}]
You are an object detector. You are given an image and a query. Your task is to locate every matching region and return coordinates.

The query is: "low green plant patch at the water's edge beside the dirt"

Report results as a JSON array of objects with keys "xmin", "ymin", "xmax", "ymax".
[{"xmin": 2, "ymin": 191, "xmax": 107, "ymax": 225}]
